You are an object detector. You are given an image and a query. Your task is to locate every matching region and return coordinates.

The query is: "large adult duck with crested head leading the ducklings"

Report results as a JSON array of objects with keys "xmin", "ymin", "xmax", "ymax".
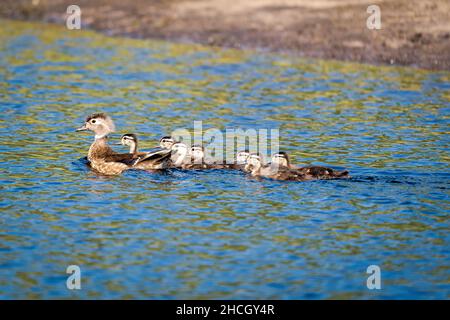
[{"xmin": 76, "ymin": 113, "xmax": 170, "ymax": 175}]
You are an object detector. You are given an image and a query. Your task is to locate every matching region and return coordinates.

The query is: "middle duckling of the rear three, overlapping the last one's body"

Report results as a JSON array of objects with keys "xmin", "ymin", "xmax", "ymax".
[{"xmin": 245, "ymin": 153, "xmax": 313, "ymax": 181}]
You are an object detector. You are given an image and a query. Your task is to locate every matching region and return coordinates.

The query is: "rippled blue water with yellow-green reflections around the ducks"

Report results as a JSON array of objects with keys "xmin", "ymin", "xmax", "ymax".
[{"xmin": 0, "ymin": 20, "xmax": 450, "ymax": 299}]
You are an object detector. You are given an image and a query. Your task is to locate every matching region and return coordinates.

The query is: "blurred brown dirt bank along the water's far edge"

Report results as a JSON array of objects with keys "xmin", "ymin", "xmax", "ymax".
[{"xmin": 0, "ymin": 0, "xmax": 450, "ymax": 70}]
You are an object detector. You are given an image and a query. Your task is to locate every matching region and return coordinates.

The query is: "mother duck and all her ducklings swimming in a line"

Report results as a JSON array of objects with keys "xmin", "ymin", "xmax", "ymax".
[{"xmin": 76, "ymin": 113, "xmax": 349, "ymax": 181}]
